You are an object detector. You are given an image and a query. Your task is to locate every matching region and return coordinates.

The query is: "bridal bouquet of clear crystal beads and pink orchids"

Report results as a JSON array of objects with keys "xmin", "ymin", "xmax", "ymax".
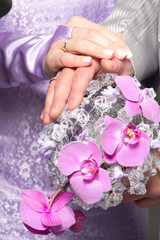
[{"xmin": 20, "ymin": 74, "xmax": 160, "ymax": 234}]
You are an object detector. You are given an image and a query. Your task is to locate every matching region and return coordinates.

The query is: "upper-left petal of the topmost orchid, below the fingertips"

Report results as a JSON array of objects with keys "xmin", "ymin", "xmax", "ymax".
[{"xmin": 115, "ymin": 76, "xmax": 141, "ymax": 101}]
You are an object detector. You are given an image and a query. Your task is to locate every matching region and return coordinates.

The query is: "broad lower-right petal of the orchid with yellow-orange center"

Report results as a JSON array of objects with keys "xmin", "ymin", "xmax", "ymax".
[{"xmin": 117, "ymin": 138, "xmax": 150, "ymax": 167}]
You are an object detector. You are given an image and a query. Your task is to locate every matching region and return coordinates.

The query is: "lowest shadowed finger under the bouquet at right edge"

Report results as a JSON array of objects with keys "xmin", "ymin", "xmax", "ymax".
[{"xmin": 133, "ymin": 197, "xmax": 160, "ymax": 208}]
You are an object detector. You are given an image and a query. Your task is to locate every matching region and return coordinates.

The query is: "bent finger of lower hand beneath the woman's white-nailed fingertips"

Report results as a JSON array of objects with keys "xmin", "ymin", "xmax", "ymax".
[{"xmin": 101, "ymin": 58, "xmax": 134, "ymax": 76}]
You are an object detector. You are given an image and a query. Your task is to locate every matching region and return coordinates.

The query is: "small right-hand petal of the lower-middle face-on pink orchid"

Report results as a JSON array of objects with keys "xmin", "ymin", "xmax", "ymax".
[{"xmin": 95, "ymin": 168, "xmax": 112, "ymax": 192}]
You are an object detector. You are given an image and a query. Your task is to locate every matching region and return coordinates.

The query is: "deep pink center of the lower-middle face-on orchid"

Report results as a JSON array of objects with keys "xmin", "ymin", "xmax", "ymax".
[{"xmin": 81, "ymin": 159, "xmax": 99, "ymax": 180}]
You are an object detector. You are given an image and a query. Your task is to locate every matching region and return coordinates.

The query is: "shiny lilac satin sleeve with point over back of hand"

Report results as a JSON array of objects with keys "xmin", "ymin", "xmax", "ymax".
[{"xmin": 0, "ymin": 26, "xmax": 72, "ymax": 88}]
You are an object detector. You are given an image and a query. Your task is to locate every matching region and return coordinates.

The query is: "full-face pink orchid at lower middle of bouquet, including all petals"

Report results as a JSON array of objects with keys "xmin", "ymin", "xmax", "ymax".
[{"xmin": 58, "ymin": 142, "xmax": 111, "ymax": 204}]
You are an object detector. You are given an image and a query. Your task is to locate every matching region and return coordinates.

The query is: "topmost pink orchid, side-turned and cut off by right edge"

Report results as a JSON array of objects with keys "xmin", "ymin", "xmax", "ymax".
[{"xmin": 115, "ymin": 76, "xmax": 160, "ymax": 122}]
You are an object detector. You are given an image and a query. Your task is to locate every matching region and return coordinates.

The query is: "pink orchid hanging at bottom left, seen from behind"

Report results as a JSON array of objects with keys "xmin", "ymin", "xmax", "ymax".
[{"xmin": 20, "ymin": 189, "xmax": 75, "ymax": 235}]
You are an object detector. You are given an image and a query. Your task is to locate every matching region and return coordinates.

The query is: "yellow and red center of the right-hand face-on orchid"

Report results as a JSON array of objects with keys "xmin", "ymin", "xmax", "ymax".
[{"xmin": 123, "ymin": 125, "xmax": 141, "ymax": 143}]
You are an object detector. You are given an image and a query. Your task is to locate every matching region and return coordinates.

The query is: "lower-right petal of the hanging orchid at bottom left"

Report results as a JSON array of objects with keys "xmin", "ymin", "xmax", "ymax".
[{"xmin": 51, "ymin": 206, "xmax": 75, "ymax": 233}]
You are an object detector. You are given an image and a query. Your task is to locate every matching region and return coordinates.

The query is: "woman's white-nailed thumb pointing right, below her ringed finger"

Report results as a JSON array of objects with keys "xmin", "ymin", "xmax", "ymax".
[{"xmin": 45, "ymin": 48, "xmax": 92, "ymax": 76}]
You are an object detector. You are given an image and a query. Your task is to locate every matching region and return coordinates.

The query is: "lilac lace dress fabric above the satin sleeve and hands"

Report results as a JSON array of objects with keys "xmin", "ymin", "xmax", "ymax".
[{"xmin": 0, "ymin": 0, "xmax": 113, "ymax": 34}]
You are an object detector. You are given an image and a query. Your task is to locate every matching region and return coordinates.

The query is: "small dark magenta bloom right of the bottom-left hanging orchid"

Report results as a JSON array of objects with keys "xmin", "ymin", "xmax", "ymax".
[{"xmin": 70, "ymin": 209, "xmax": 86, "ymax": 232}]
